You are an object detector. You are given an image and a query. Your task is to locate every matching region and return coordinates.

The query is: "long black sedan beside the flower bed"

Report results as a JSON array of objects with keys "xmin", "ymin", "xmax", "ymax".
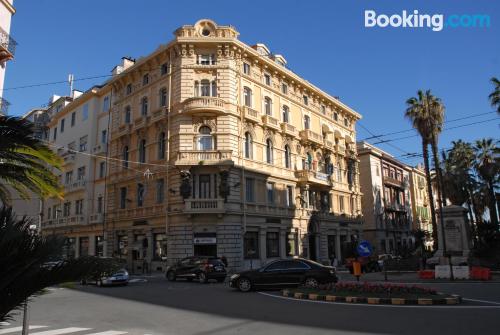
[{"xmin": 229, "ymin": 258, "xmax": 338, "ymax": 292}]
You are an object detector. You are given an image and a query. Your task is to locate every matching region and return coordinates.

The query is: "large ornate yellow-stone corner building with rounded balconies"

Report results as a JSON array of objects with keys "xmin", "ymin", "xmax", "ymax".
[{"xmin": 106, "ymin": 20, "xmax": 362, "ymax": 270}]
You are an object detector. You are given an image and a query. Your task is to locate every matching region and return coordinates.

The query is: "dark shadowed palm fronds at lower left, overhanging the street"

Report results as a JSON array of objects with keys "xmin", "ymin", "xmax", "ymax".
[{"xmin": 0, "ymin": 207, "xmax": 116, "ymax": 322}]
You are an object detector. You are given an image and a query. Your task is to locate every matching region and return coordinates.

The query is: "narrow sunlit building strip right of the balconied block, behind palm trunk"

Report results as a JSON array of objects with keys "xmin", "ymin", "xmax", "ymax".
[{"xmin": 410, "ymin": 165, "xmax": 433, "ymax": 248}]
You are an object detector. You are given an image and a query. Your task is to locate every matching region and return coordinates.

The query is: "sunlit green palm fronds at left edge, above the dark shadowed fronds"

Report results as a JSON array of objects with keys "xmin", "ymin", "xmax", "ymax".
[{"xmin": 0, "ymin": 115, "xmax": 62, "ymax": 204}]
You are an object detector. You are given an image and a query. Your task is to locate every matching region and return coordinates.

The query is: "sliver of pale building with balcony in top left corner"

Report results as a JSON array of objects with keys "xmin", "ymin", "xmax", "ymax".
[{"xmin": 0, "ymin": 0, "xmax": 17, "ymax": 115}]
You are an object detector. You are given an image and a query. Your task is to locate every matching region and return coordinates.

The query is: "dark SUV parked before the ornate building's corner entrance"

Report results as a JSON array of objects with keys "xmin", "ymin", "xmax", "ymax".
[{"xmin": 166, "ymin": 256, "xmax": 227, "ymax": 283}]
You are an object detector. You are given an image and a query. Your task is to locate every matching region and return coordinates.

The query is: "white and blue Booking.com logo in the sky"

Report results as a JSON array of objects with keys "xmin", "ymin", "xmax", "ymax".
[{"xmin": 365, "ymin": 10, "xmax": 490, "ymax": 31}]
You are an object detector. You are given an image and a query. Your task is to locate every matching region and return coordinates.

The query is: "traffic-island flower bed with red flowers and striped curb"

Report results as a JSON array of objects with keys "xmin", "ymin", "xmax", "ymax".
[{"xmin": 282, "ymin": 282, "xmax": 461, "ymax": 305}]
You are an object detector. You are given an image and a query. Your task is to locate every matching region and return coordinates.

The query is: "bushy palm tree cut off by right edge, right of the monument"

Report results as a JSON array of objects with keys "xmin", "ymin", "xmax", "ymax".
[{"xmin": 474, "ymin": 138, "xmax": 500, "ymax": 226}]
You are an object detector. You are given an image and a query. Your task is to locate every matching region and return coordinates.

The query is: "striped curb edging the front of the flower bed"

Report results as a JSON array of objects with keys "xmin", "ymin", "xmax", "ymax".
[{"xmin": 281, "ymin": 290, "xmax": 462, "ymax": 305}]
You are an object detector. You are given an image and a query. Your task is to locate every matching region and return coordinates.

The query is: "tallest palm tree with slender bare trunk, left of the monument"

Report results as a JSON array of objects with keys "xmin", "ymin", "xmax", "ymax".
[{"xmin": 405, "ymin": 90, "xmax": 444, "ymax": 249}]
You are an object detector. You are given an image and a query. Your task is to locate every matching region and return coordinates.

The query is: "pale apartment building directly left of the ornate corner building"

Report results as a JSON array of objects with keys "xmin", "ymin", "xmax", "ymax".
[{"xmin": 42, "ymin": 85, "xmax": 111, "ymax": 257}]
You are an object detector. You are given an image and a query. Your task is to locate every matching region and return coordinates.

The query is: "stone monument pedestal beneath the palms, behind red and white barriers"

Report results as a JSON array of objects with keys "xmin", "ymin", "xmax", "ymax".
[{"xmin": 434, "ymin": 205, "xmax": 472, "ymax": 265}]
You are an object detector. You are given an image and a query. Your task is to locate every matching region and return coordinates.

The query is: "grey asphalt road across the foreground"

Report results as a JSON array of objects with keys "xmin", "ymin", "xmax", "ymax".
[{"xmin": 0, "ymin": 278, "xmax": 500, "ymax": 335}]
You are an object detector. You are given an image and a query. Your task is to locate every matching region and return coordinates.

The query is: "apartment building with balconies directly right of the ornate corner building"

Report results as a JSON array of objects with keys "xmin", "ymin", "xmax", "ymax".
[{"xmin": 357, "ymin": 142, "xmax": 413, "ymax": 254}]
